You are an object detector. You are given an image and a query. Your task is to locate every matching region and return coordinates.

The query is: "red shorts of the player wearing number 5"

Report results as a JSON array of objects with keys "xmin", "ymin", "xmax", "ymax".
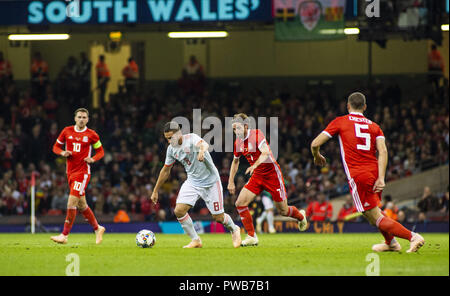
[{"xmin": 348, "ymin": 172, "xmax": 381, "ymax": 212}]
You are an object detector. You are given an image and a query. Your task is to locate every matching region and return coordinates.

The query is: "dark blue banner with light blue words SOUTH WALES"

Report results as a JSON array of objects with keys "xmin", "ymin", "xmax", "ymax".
[{"xmin": 0, "ymin": 0, "xmax": 272, "ymax": 25}]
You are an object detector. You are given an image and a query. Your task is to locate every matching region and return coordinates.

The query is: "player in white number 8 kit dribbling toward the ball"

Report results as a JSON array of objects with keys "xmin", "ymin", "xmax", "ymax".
[{"xmin": 151, "ymin": 121, "xmax": 241, "ymax": 248}]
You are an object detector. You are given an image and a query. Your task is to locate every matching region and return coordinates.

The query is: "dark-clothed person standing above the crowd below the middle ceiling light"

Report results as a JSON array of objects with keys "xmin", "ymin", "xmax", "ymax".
[{"xmin": 178, "ymin": 55, "xmax": 205, "ymax": 95}]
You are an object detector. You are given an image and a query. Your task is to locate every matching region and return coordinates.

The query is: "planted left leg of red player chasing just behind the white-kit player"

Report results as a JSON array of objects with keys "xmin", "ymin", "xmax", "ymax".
[{"xmin": 235, "ymin": 187, "xmax": 259, "ymax": 247}]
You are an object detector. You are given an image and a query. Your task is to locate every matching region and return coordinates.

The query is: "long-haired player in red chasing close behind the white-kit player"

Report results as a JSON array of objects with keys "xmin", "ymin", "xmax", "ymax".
[{"xmin": 228, "ymin": 113, "xmax": 308, "ymax": 246}]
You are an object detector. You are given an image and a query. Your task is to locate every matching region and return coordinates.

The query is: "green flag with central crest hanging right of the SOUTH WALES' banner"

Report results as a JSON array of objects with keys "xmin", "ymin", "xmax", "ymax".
[{"xmin": 273, "ymin": 0, "xmax": 346, "ymax": 41}]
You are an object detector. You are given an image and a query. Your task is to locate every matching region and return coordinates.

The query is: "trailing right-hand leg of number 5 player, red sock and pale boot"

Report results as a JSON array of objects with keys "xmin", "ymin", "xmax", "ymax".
[{"xmin": 363, "ymin": 207, "xmax": 425, "ymax": 253}]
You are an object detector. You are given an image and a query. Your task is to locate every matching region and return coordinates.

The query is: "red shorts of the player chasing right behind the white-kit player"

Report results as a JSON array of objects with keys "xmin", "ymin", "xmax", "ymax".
[{"xmin": 244, "ymin": 168, "xmax": 287, "ymax": 202}]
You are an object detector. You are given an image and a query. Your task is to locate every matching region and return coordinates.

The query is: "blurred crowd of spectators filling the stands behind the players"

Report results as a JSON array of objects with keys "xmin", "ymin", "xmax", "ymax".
[{"xmin": 0, "ymin": 55, "xmax": 449, "ymax": 221}]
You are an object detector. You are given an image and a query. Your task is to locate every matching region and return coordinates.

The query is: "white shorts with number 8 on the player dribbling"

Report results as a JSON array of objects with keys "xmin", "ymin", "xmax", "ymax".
[{"xmin": 177, "ymin": 180, "xmax": 224, "ymax": 215}]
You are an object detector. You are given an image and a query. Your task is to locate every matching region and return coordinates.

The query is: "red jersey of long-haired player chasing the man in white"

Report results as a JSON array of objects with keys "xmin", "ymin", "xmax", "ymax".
[{"xmin": 233, "ymin": 129, "xmax": 278, "ymax": 174}]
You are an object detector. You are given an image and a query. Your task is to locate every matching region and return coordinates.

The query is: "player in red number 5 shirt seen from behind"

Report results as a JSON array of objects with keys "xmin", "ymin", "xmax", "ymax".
[{"xmin": 311, "ymin": 92, "xmax": 425, "ymax": 253}]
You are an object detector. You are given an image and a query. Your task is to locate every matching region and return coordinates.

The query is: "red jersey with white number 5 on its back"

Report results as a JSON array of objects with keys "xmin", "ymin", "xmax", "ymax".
[{"xmin": 323, "ymin": 112, "xmax": 384, "ymax": 180}]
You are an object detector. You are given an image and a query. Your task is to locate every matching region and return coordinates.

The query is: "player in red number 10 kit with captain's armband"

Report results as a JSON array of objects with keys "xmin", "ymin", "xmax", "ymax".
[{"xmin": 50, "ymin": 108, "xmax": 105, "ymax": 244}]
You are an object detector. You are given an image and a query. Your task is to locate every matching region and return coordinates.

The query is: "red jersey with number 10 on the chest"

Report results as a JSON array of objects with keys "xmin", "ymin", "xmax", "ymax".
[{"xmin": 56, "ymin": 125, "xmax": 101, "ymax": 176}]
